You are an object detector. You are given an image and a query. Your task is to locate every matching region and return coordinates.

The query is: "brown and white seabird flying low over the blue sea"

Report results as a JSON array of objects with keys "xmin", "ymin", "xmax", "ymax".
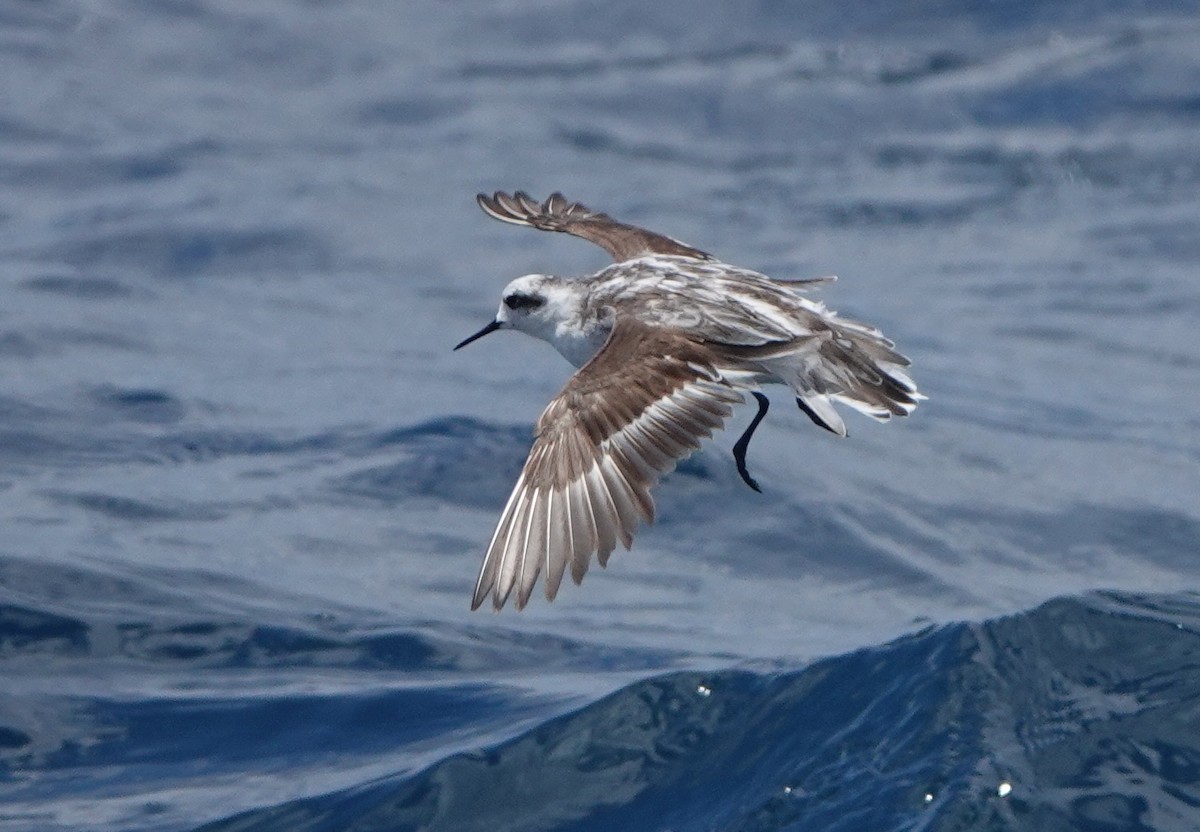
[{"xmin": 455, "ymin": 191, "xmax": 925, "ymax": 610}]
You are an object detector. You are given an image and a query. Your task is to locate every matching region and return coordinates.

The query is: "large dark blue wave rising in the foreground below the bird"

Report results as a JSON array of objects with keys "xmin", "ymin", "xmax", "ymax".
[{"xmin": 202, "ymin": 594, "xmax": 1200, "ymax": 832}]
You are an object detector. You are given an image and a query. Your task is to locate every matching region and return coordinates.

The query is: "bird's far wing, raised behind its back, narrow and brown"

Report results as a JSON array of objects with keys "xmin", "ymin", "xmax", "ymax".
[{"xmin": 475, "ymin": 191, "xmax": 713, "ymax": 263}]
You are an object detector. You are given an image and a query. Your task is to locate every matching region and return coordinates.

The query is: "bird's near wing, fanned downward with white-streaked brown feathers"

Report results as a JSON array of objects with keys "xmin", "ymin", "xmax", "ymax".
[{"xmin": 472, "ymin": 319, "xmax": 743, "ymax": 610}]
